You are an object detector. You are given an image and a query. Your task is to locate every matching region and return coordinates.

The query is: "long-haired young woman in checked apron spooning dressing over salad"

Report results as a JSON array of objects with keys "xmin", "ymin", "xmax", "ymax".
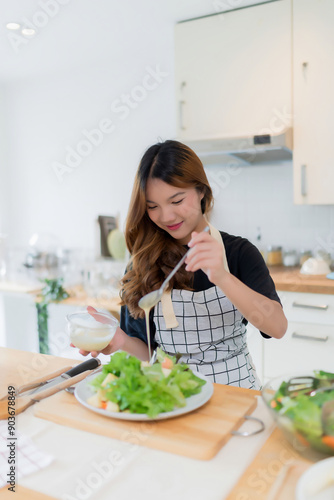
[{"xmin": 81, "ymin": 141, "xmax": 287, "ymax": 389}]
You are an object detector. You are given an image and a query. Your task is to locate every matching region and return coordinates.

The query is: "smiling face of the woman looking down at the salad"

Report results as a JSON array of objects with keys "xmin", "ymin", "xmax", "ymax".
[{"xmin": 146, "ymin": 179, "xmax": 207, "ymax": 245}]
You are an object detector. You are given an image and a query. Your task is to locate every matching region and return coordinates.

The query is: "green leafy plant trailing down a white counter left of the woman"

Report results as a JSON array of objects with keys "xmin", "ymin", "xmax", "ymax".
[{"xmin": 36, "ymin": 278, "xmax": 69, "ymax": 354}]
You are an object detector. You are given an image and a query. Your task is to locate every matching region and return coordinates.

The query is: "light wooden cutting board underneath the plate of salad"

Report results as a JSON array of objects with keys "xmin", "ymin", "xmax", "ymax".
[{"xmin": 34, "ymin": 384, "xmax": 258, "ymax": 460}]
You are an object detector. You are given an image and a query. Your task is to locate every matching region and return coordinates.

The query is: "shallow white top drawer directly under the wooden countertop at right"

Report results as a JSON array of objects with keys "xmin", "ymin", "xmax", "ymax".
[{"xmin": 279, "ymin": 292, "xmax": 334, "ymax": 325}]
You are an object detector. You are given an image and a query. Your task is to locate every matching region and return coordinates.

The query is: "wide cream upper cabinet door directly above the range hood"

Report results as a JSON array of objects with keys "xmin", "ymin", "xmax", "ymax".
[{"xmin": 175, "ymin": 0, "xmax": 292, "ymax": 139}]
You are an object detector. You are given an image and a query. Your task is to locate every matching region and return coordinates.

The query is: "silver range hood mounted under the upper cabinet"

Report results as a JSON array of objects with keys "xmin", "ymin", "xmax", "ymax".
[{"xmin": 183, "ymin": 128, "xmax": 292, "ymax": 165}]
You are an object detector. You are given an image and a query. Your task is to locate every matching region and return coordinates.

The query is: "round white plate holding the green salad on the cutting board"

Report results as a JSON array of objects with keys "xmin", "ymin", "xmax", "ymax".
[{"xmin": 74, "ymin": 372, "xmax": 213, "ymax": 421}]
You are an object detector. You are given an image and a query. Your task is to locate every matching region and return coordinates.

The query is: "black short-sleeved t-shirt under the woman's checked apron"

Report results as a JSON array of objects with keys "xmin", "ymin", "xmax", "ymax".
[{"xmin": 120, "ymin": 231, "xmax": 281, "ymax": 346}]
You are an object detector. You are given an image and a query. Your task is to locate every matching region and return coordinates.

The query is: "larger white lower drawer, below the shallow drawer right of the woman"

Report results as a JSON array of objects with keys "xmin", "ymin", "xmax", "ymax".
[{"xmin": 263, "ymin": 322, "xmax": 334, "ymax": 381}]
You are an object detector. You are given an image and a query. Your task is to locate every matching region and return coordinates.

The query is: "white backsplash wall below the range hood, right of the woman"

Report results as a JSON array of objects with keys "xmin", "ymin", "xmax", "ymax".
[{"xmin": 206, "ymin": 162, "xmax": 334, "ymax": 258}]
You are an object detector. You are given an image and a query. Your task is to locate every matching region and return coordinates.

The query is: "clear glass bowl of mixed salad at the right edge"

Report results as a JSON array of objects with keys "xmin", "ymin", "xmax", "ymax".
[{"xmin": 262, "ymin": 370, "xmax": 334, "ymax": 459}]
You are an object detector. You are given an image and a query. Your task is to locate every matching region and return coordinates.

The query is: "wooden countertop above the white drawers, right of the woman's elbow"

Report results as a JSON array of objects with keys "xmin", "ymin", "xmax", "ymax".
[{"xmin": 269, "ymin": 266, "xmax": 334, "ymax": 295}]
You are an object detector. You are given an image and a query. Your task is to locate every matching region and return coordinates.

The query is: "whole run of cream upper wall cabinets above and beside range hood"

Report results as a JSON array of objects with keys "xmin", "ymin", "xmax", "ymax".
[{"xmin": 175, "ymin": 0, "xmax": 334, "ymax": 204}]
